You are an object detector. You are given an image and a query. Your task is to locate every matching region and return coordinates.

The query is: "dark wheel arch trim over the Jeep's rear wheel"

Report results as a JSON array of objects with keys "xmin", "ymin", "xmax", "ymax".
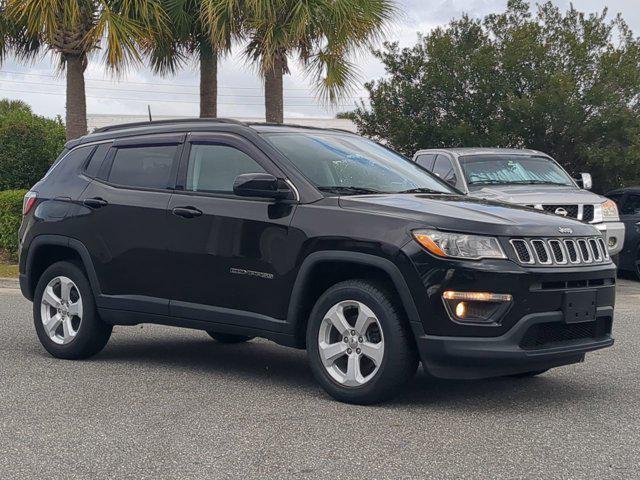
[{"xmin": 20, "ymin": 235, "xmax": 100, "ymax": 300}]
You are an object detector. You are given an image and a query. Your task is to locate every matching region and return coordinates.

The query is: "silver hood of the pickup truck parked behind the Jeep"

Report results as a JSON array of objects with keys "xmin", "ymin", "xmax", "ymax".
[{"xmin": 469, "ymin": 185, "xmax": 606, "ymax": 205}]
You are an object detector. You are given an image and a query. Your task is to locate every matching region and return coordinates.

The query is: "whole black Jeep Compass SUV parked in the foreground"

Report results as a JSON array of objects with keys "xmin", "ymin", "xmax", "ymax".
[{"xmin": 20, "ymin": 120, "xmax": 615, "ymax": 403}]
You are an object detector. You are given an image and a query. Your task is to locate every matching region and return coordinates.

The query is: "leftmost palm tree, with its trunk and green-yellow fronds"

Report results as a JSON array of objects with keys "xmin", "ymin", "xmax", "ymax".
[{"xmin": 0, "ymin": 0, "xmax": 168, "ymax": 139}]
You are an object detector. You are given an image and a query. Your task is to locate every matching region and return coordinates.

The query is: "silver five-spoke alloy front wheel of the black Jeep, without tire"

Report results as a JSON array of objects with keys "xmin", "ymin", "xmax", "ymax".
[{"xmin": 318, "ymin": 300, "xmax": 384, "ymax": 387}]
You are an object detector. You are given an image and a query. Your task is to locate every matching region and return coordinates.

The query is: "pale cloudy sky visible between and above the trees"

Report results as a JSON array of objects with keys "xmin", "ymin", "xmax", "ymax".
[{"xmin": 0, "ymin": 0, "xmax": 640, "ymax": 118}]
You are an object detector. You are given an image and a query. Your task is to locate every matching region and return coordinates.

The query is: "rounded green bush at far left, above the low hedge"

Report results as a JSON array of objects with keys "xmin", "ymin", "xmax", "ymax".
[{"xmin": 0, "ymin": 100, "xmax": 65, "ymax": 190}]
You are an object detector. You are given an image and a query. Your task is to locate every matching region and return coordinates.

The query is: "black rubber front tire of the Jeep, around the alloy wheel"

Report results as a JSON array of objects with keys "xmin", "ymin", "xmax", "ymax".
[{"xmin": 306, "ymin": 281, "xmax": 418, "ymax": 404}]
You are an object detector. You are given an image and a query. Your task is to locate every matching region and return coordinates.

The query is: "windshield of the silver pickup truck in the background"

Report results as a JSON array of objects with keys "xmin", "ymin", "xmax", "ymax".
[{"xmin": 460, "ymin": 155, "xmax": 574, "ymax": 187}]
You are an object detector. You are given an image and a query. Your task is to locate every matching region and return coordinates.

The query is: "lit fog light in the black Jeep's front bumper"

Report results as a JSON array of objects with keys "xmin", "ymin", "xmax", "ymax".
[{"xmin": 442, "ymin": 290, "xmax": 513, "ymax": 324}]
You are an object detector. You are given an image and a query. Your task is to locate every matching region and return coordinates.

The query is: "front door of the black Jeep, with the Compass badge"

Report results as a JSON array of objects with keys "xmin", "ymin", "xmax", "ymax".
[{"xmin": 162, "ymin": 133, "xmax": 302, "ymax": 329}]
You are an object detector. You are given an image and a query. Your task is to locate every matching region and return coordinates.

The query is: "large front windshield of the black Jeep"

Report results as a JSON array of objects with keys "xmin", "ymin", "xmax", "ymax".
[{"xmin": 264, "ymin": 131, "xmax": 454, "ymax": 195}]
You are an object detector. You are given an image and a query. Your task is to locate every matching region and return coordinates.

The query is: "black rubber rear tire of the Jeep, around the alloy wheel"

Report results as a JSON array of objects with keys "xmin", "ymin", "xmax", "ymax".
[{"xmin": 33, "ymin": 262, "xmax": 111, "ymax": 359}]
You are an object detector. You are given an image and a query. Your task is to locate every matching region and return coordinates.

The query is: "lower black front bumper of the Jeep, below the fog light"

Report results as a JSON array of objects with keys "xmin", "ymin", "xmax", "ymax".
[{"xmin": 416, "ymin": 307, "xmax": 614, "ymax": 379}]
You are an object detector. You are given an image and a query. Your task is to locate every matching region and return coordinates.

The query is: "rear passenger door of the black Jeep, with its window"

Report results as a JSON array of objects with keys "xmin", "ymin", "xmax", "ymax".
[{"xmin": 81, "ymin": 134, "xmax": 185, "ymax": 314}]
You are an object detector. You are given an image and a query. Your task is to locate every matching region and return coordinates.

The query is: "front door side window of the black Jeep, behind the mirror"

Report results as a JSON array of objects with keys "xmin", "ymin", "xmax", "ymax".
[{"xmin": 187, "ymin": 144, "xmax": 264, "ymax": 193}]
